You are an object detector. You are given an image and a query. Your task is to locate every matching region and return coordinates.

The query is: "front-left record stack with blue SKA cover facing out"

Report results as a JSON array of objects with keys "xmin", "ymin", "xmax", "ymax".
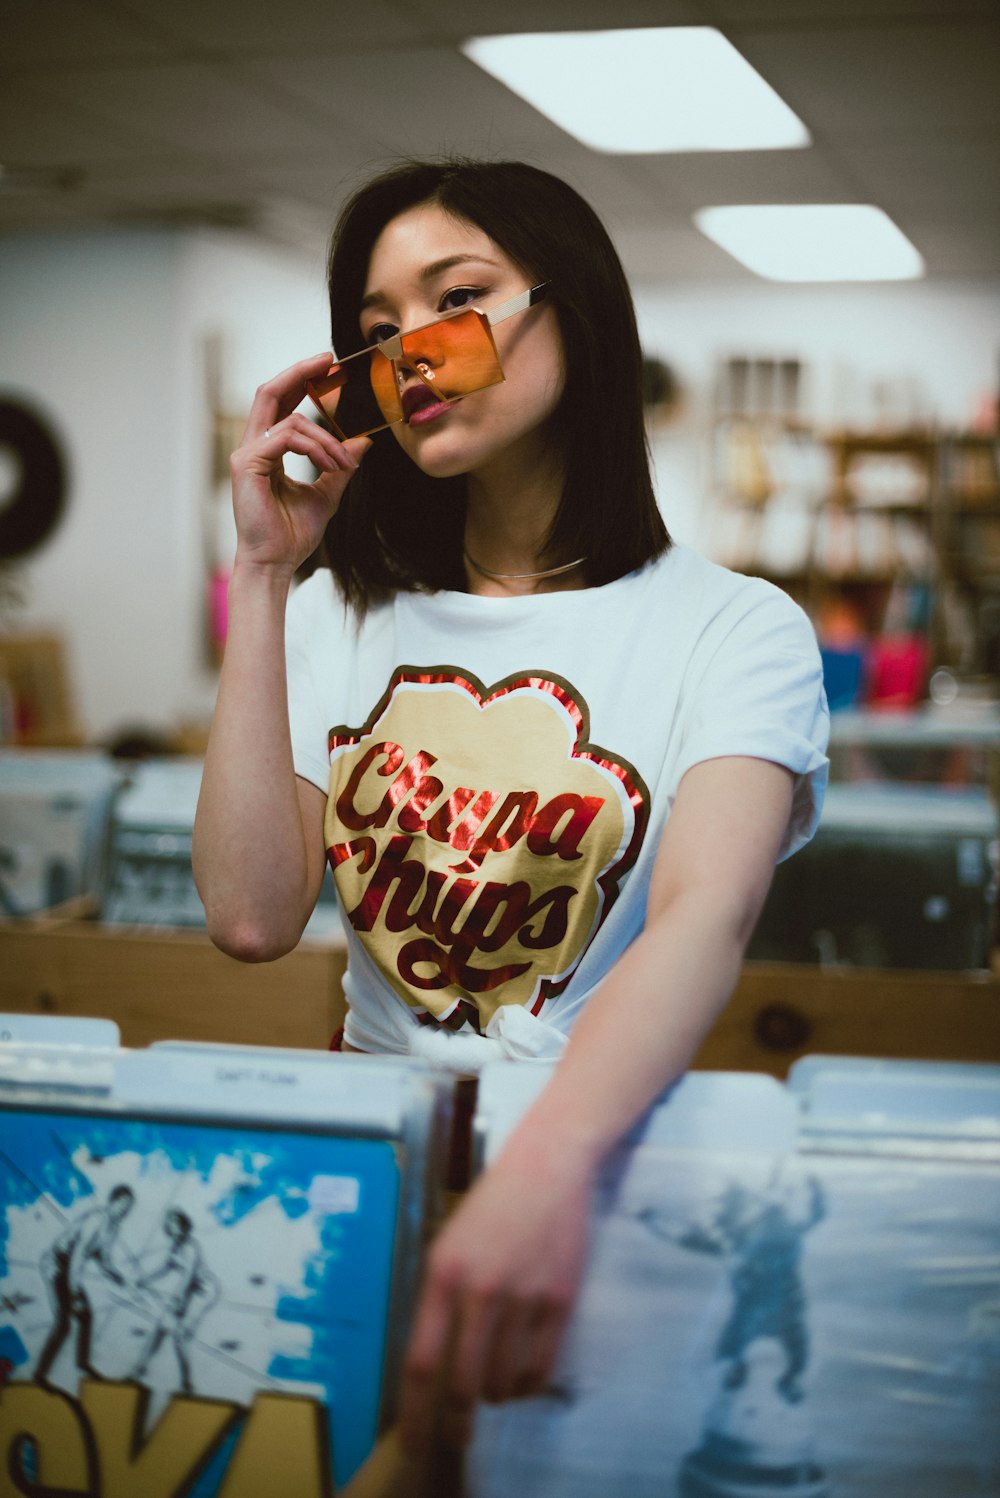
[{"xmin": 0, "ymin": 1044, "xmax": 451, "ymax": 1498}]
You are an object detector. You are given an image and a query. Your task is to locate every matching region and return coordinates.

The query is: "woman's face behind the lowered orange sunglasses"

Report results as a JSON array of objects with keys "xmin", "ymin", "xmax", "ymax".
[{"xmin": 361, "ymin": 204, "xmax": 564, "ymax": 478}]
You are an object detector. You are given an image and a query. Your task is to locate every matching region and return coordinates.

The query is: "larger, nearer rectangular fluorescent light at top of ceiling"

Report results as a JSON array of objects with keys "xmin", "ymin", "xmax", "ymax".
[{"xmin": 461, "ymin": 25, "xmax": 810, "ymax": 153}]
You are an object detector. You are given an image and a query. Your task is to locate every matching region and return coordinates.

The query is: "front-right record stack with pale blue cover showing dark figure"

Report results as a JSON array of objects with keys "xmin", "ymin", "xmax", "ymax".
[{"xmin": 470, "ymin": 1059, "xmax": 1000, "ymax": 1498}]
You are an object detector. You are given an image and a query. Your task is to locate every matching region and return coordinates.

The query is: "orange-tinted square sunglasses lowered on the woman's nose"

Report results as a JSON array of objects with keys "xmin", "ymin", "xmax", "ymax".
[{"xmin": 305, "ymin": 282, "xmax": 549, "ymax": 442}]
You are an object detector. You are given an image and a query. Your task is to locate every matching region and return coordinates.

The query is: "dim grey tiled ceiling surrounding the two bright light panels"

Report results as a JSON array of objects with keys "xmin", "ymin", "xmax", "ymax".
[{"xmin": 0, "ymin": 0, "xmax": 1000, "ymax": 282}]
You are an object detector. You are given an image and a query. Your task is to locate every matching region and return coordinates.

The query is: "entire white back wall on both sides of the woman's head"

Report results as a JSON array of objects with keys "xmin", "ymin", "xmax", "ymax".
[{"xmin": 0, "ymin": 231, "xmax": 1000, "ymax": 739}]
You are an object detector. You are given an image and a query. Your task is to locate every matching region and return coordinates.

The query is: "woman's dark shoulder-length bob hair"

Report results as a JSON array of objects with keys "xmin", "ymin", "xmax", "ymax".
[{"xmin": 315, "ymin": 159, "xmax": 671, "ymax": 613}]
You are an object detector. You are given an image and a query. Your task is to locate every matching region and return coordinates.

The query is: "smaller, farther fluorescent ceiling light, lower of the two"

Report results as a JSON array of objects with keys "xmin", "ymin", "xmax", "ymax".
[{"xmin": 695, "ymin": 202, "xmax": 924, "ymax": 282}]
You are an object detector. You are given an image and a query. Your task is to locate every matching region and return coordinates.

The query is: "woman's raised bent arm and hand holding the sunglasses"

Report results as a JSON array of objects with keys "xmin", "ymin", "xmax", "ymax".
[{"xmin": 193, "ymin": 355, "xmax": 368, "ymax": 962}]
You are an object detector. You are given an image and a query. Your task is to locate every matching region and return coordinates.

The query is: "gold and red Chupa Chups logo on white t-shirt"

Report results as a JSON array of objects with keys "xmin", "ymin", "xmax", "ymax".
[{"xmin": 326, "ymin": 667, "xmax": 648, "ymax": 1028}]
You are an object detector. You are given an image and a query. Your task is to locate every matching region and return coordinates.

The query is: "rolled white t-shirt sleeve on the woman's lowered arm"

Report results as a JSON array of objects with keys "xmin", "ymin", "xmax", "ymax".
[{"xmin": 677, "ymin": 583, "xmax": 829, "ymax": 861}]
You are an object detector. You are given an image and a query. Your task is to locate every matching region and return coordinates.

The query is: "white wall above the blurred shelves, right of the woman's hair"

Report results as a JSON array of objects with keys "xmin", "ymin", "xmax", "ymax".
[{"xmin": 636, "ymin": 280, "xmax": 1000, "ymax": 544}]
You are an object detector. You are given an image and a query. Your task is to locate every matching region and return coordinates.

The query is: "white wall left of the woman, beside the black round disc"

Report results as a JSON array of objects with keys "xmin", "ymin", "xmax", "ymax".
[{"xmin": 0, "ymin": 232, "xmax": 328, "ymax": 739}]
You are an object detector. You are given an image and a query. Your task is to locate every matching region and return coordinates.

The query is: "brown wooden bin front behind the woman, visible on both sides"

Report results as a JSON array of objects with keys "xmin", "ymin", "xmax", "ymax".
[{"xmin": 0, "ymin": 921, "xmax": 1000, "ymax": 1079}]
